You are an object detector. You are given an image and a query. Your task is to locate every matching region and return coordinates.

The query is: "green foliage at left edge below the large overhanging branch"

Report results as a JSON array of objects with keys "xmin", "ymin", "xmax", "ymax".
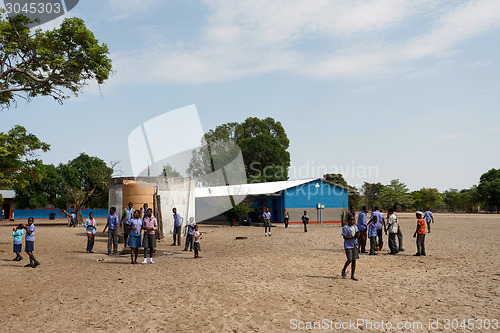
[{"xmin": 0, "ymin": 125, "xmax": 50, "ymax": 189}]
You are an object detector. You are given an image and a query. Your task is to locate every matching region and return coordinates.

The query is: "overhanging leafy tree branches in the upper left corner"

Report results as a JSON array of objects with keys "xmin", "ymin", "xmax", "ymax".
[{"xmin": 0, "ymin": 14, "xmax": 112, "ymax": 108}]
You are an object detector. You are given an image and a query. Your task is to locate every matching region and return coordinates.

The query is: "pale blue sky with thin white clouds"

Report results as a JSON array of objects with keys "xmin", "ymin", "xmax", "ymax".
[{"xmin": 0, "ymin": 0, "xmax": 500, "ymax": 191}]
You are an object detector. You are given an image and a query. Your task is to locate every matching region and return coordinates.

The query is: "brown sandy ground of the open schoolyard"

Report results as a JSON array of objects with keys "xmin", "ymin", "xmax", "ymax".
[{"xmin": 0, "ymin": 214, "xmax": 500, "ymax": 332}]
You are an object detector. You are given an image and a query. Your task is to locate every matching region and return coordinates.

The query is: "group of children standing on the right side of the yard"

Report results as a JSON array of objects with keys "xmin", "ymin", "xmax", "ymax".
[{"xmin": 341, "ymin": 206, "xmax": 434, "ymax": 281}]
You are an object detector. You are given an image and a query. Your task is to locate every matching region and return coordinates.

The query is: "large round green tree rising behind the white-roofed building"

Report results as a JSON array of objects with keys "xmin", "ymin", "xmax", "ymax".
[{"xmin": 188, "ymin": 117, "xmax": 290, "ymax": 186}]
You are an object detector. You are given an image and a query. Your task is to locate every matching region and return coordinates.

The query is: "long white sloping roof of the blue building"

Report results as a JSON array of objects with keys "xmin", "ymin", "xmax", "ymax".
[{"xmin": 195, "ymin": 178, "xmax": 317, "ymax": 198}]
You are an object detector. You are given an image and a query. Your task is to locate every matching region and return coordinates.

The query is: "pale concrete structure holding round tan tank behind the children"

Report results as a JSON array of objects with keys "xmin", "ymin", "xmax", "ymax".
[{"xmin": 109, "ymin": 177, "xmax": 195, "ymax": 236}]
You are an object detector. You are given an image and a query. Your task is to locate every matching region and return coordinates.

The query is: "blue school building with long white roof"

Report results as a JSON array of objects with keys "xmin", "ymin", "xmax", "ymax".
[{"xmin": 196, "ymin": 178, "xmax": 352, "ymax": 223}]
